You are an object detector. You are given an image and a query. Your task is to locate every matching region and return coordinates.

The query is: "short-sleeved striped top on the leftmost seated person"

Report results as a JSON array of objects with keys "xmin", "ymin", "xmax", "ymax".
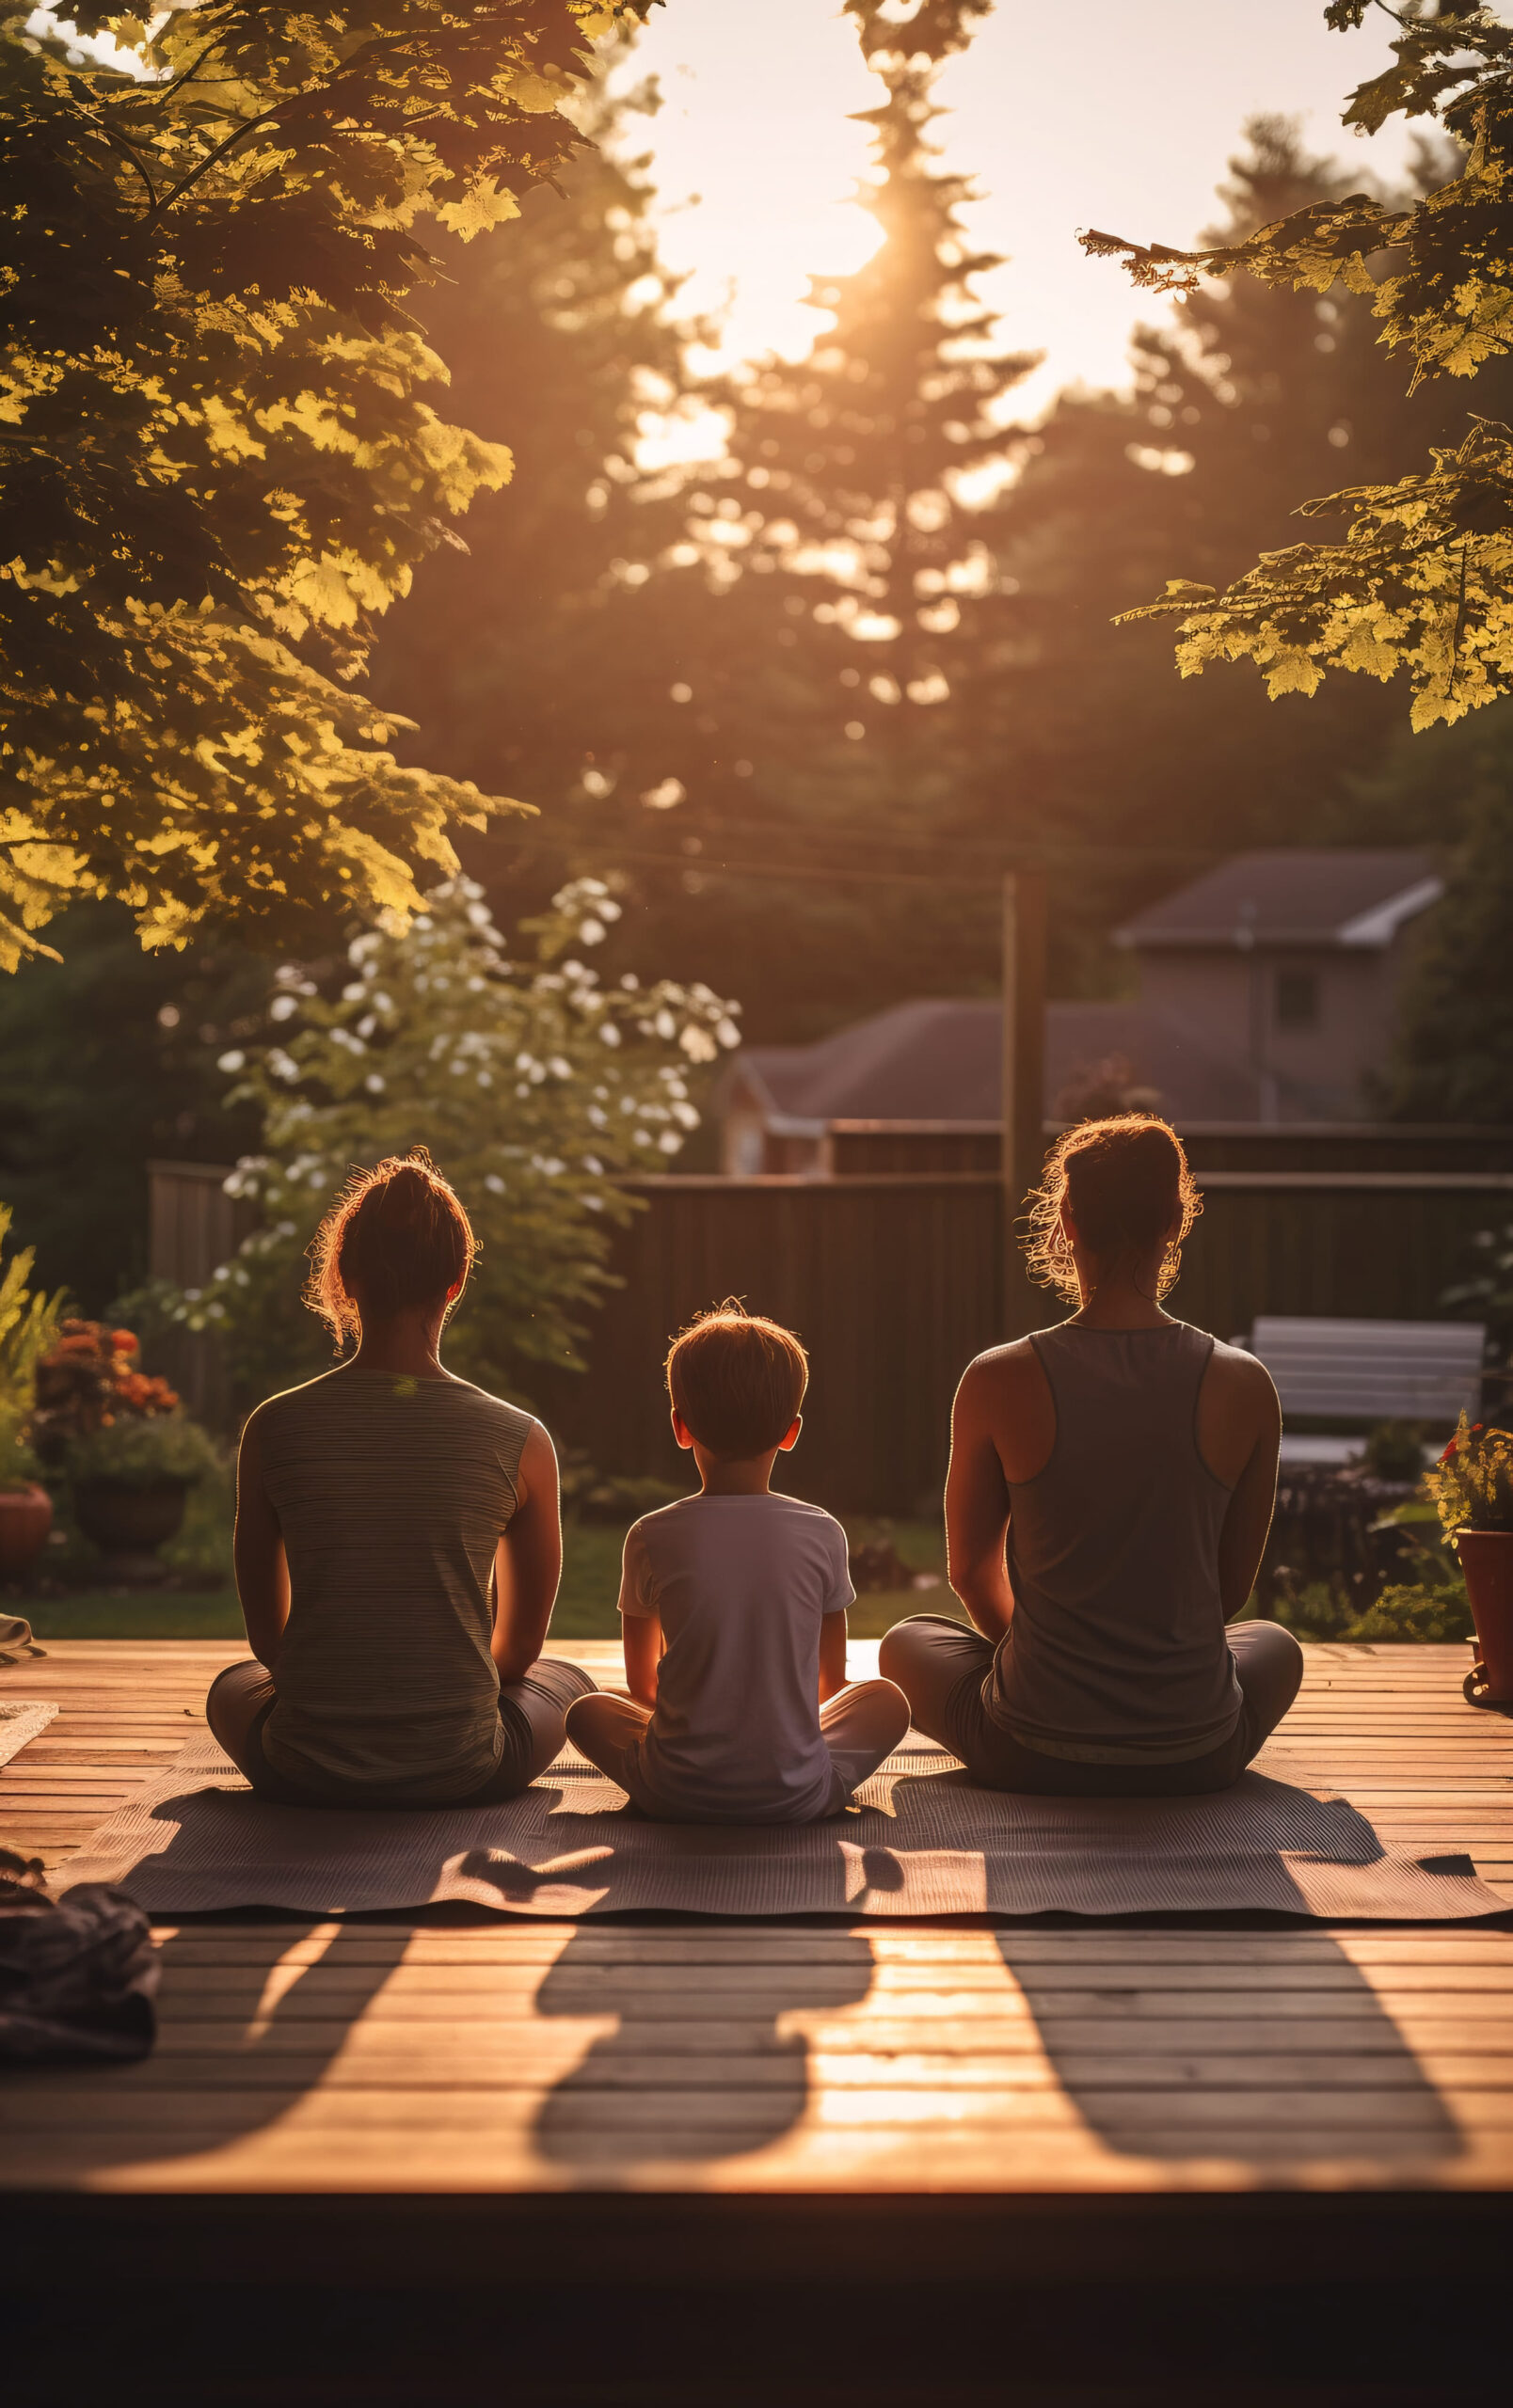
[{"xmin": 253, "ymin": 1368, "xmax": 533, "ymax": 1803}]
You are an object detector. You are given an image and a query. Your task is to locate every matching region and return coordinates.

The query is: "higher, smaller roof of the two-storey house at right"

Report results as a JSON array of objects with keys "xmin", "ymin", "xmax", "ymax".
[{"xmin": 1116, "ymin": 846, "xmax": 1443, "ymax": 949}]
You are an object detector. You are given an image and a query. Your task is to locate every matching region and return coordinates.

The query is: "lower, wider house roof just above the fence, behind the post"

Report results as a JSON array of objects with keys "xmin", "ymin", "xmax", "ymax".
[{"xmin": 725, "ymin": 1002, "xmax": 1308, "ymax": 1136}]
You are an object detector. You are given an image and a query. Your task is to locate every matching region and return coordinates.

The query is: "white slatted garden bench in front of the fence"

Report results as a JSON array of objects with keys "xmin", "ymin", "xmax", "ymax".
[{"xmin": 1250, "ymin": 1315, "xmax": 1487, "ymax": 1464}]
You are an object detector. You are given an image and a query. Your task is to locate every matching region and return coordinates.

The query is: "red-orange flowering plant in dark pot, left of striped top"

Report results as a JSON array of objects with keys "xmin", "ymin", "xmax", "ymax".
[{"xmin": 31, "ymin": 1320, "xmax": 216, "ymax": 1584}]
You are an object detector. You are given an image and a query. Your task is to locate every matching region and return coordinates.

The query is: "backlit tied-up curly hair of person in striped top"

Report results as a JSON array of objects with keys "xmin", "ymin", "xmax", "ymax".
[{"xmin": 304, "ymin": 1147, "xmax": 477, "ymax": 1354}]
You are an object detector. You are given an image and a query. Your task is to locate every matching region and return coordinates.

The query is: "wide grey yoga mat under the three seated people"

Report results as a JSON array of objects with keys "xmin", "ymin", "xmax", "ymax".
[{"xmin": 57, "ymin": 1738, "xmax": 1505, "ymax": 1922}]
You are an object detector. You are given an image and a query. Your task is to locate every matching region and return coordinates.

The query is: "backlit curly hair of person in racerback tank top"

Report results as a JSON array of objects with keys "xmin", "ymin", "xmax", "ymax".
[{"xmin": 1024, "ymin": 1113, "xmax": 1202, "ymax": 1306}]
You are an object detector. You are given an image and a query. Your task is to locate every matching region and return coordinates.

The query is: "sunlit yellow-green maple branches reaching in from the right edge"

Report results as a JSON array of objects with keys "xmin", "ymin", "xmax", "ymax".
[{"xmin": 1082, "ymin": 0, "xmax": 1513, "ymax": 730}]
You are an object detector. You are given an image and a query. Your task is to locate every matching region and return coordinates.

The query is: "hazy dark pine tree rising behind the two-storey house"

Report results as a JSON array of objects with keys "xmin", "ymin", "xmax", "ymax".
[{"xmin": 1000, "ymin": 118, "xmax": 1513, "ymax": 968}]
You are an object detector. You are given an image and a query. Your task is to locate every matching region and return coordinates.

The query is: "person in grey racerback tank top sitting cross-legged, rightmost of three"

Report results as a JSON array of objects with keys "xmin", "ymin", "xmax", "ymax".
[{"xmin": 880, "ymin": 1113, "xmax": 1303, "ymax": 1797}]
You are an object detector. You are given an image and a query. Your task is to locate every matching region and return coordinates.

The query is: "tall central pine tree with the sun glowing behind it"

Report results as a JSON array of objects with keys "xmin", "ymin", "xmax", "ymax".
[{"xmin": 559, "ymin": 0, "xmax": 1031, "ymax": 1038}]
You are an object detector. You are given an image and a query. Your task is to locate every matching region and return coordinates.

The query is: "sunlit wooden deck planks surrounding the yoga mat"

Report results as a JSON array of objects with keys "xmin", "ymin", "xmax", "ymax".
[{"xmin": 0, "ymin": 1640, "xmax": 1513, "ymax": 2196}]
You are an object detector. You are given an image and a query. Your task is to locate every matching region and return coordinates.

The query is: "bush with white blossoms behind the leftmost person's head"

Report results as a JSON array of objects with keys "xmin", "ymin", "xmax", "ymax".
[{"xmin": 168, "ymin": 879, "xmax": 740, "ymax": 1397}]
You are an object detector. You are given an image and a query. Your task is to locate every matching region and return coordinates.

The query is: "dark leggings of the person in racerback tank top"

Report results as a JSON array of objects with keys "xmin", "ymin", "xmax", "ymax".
[{"xmin": 877, "ymin": 1613, "xmax": 1303, "ymax": 1798}]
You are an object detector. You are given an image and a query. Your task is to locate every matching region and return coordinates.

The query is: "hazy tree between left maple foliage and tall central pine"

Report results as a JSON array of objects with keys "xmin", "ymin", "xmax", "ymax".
[{"xmin": 374, "ymin": 68, "xmax": 689, "ymax": 818}]
